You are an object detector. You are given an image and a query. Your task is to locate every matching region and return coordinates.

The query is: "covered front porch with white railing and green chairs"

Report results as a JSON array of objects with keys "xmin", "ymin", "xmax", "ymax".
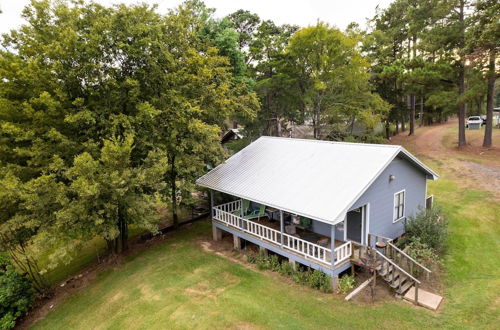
[{"xmin": 212, "ymin": 199, "xmax": 355, "ymax": 275}]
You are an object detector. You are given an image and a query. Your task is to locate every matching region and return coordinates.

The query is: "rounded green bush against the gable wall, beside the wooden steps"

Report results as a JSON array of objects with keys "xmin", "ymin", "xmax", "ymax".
[{"xmin": 399, "ymin": 208, "xmax": 447, "ymax": 252}]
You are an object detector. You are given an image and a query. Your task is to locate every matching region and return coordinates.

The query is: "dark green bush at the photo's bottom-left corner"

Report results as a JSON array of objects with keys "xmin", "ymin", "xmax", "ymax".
[{"xmin": 0, "ymin": 254, "xmax": 34, "ymax": 330}]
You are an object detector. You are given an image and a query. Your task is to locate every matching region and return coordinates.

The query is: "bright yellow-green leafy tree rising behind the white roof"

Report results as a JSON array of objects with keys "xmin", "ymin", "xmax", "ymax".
[{"xmin": 287, "ymin": 23, "xmax": 388, "ymax": 139}]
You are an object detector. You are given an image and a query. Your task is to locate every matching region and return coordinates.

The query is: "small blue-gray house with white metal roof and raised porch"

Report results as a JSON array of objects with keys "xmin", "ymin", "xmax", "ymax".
[{"xmin": 197, "ymin": 137, "xmax": 438, "ymax": 292}]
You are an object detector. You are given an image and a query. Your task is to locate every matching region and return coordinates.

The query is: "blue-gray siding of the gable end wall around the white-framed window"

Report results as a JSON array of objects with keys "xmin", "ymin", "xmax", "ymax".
[{"xmin": 352, "ymin": 158, "xmax": 427, "ymax": 238}]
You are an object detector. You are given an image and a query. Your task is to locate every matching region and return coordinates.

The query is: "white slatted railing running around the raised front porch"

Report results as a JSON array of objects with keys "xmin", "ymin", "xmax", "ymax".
[{"xmin": 212, "ymin": 200, "xmax": 352, "ymax": 265}]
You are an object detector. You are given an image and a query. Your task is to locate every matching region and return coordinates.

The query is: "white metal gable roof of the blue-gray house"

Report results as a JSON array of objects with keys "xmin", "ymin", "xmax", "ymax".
[{"xmin": 196, "ymin": 137, "xmax": 437, "ymax": 223}]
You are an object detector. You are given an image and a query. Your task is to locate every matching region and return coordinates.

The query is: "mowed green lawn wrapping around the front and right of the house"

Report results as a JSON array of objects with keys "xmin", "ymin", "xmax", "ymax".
[{"xmin": 35, "ymin": 171, "xmax": 500, "ymax": 329}]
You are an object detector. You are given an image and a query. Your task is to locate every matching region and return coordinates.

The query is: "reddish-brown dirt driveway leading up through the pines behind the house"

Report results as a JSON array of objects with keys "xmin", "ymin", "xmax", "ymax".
[{"xmin": 391, "ymin": 119, "xmax": 500, "ymax": 201}]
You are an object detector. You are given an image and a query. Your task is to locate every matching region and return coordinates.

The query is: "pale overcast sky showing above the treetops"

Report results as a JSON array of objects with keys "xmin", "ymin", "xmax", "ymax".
[{"xmin": 0, "ymin": 0, "xmax": 392, "ymax": 34}]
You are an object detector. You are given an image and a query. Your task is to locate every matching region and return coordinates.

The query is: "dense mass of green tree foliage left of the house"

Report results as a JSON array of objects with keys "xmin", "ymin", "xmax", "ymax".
[{"xmin": 0, "ymin": 0, "xmax": 258, "ymax": 278}]
